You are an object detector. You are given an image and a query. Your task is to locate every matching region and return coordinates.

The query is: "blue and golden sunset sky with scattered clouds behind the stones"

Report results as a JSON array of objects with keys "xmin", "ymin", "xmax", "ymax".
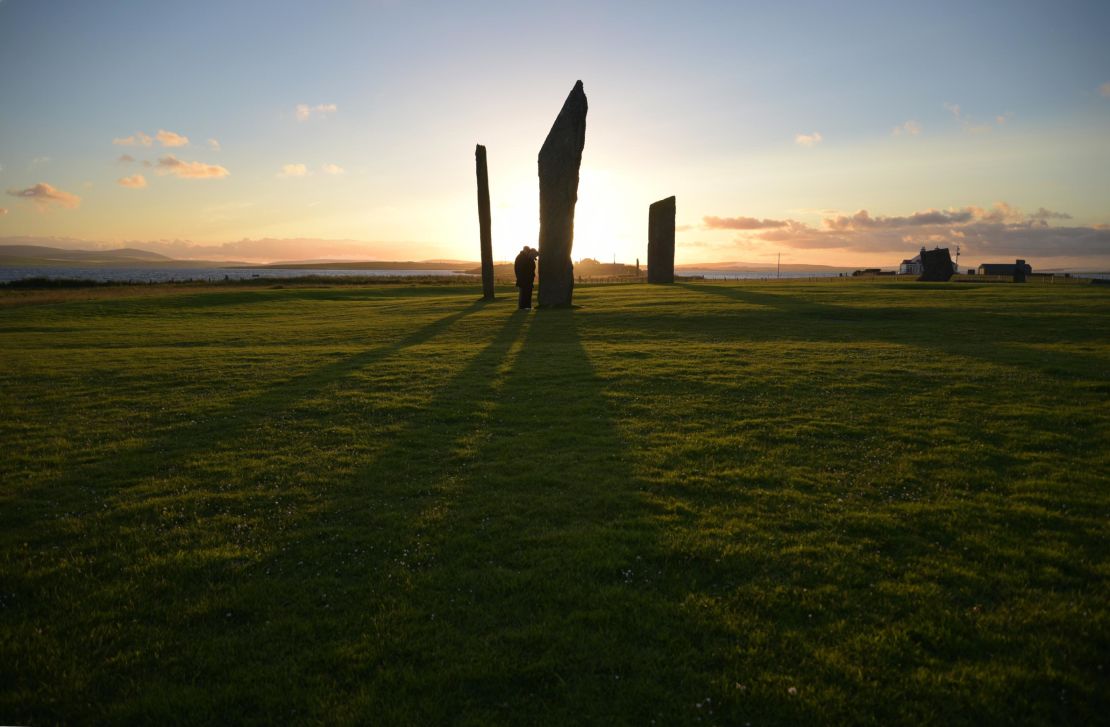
[{"xmin": 0, "ymin": 0, "xmax": 1110, "ymax": 269}]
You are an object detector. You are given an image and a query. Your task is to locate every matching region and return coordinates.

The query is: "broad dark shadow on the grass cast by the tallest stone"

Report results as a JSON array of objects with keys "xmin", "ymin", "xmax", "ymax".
[{"xmin": 310, "ymin": 311, "xmax": 815, "ymax": 724}]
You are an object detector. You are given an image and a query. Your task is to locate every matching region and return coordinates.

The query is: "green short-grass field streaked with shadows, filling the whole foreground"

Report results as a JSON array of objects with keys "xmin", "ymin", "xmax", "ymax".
[{"xmin": 0, "ymin": 282, "xmax": 1110, "ymax": 725}]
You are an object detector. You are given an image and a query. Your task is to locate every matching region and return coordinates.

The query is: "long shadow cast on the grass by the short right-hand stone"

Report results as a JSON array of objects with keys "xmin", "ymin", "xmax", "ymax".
[{"xmin": 682, "ymin": 279, "xmax": 1107, "ymax": 512}]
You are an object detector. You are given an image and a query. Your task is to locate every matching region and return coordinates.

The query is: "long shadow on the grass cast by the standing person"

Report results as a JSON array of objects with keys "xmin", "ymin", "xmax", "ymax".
[{"xmin": 46, "ymin": 306, "xmax": 527, "ymax": 721}]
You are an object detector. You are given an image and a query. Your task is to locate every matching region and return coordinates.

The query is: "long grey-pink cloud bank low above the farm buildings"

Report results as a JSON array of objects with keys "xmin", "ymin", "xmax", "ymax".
[{"xmin": 706, "ymin": 202, "xmax": 1110, "ymax": 260}]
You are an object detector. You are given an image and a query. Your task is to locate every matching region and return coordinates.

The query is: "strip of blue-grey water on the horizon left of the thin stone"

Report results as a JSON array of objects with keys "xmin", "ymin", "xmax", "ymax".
[{"xmin": 0, "ymin": 267, "xmax": 473, "ymax": 283}]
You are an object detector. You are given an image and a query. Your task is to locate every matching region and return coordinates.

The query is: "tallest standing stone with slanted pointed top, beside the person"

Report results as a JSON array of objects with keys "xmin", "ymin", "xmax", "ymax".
[{"xmin": 539, "ymin": 81, "xmax": 587, "ymax": 307}]
